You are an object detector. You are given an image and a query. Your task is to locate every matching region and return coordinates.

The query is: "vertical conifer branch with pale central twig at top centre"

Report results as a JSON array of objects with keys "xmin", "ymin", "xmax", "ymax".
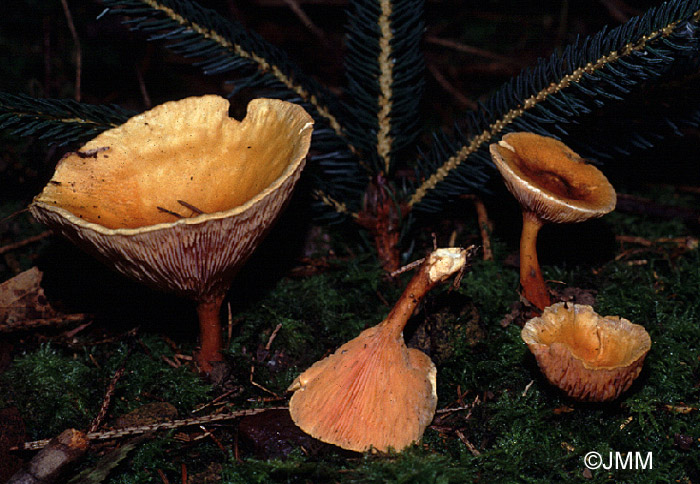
[{"xmin": 345, "ymin": 0, "xmax": 424, "ymax": 177}]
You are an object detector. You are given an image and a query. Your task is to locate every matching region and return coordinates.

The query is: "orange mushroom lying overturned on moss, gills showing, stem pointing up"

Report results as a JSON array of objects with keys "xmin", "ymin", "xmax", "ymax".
[{"xmin": 289, "ymin": 248, "xmax": 466, "ymax": 452}]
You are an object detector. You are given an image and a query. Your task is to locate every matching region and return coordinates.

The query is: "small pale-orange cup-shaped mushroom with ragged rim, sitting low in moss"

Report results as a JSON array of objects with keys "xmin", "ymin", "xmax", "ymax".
[{"xmin": 521, "ymin": 302, "xmax": 651, "ymax": 402}]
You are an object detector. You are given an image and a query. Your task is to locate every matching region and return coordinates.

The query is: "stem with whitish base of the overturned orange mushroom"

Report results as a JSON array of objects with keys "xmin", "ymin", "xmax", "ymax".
[{"xmin": 379, "ymin": 248, "xmax": 466, "ymax": 337}]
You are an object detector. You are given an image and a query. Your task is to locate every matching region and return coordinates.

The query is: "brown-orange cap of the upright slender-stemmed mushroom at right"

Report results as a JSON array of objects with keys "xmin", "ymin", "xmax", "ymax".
[{"xmin": 490, "ymin": 132, "xmax": 617, "ymax": 223}]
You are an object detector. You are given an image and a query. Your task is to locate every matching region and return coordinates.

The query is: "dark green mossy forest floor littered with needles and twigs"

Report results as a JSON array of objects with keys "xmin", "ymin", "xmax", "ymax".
[{"xmin": 0, "ymin": 182, "xmax": 700, "ymax": 484}]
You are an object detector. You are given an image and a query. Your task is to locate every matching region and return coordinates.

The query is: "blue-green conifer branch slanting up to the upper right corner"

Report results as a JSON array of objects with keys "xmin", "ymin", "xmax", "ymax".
[{"xmin": 409, "ymin": 0, "xmax": 700, "ymax": 210}]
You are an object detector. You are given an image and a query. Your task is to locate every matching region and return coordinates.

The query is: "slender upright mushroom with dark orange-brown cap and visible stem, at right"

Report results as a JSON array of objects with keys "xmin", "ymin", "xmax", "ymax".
[{"xmin": 490, "ymin": 133, "xmax": 617, "ymax": 309}]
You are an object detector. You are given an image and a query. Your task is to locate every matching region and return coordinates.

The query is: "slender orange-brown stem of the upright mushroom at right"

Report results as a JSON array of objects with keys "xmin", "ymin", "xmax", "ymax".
[{"xmin": 520, "ymin": 210, "xmax": 551, "ymax": 309}]
